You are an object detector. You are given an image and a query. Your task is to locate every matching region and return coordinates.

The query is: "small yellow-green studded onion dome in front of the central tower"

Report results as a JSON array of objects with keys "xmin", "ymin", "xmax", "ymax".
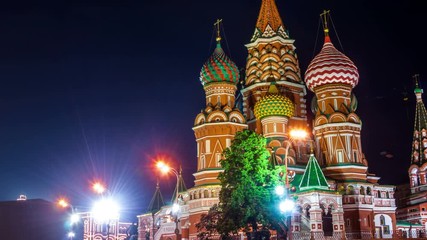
[{"xmin": 254, "ymin": 84, "xmax": 295, "ymax": 119}]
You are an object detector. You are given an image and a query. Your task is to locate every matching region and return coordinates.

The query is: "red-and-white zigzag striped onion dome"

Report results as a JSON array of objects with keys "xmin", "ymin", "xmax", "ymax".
[{"xmin": 305, "ymin": 35, "xmax": 359, "ymax": 92}]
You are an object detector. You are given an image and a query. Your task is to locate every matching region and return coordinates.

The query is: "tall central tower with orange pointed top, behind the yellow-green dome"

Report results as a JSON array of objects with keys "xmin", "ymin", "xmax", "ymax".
[{"xmin": 242, "ymin": 0, "xmax": 307, "ymax": 136}]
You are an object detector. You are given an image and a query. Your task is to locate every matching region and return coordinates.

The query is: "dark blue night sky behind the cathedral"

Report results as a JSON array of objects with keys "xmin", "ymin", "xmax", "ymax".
[{"xmin": 0, "ymin": 0, "xmax": 427, "ymax": 220}]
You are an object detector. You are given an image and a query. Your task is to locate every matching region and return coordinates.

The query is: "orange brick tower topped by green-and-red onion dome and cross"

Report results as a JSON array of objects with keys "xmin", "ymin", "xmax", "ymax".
[{"xmin": 193, "ymin": 21, "xmax": 247, "ymax": 186}]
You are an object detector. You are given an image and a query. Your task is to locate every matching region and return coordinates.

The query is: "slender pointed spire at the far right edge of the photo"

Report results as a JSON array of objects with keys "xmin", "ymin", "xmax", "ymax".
[{"xmin": 411, "ymin": 75, "xmax": 427, "ymax": 166}]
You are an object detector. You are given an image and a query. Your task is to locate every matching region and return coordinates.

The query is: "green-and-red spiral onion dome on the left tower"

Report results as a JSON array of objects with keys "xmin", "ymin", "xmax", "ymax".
[{"xmin": 200, "ymin": 42, "xmax": 239, "ymax": 86}]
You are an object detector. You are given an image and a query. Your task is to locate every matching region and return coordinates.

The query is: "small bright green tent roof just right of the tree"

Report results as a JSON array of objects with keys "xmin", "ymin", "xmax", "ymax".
[{"xmin": 299, "ymin": 154, "xmax": 329, "ymax": 191}]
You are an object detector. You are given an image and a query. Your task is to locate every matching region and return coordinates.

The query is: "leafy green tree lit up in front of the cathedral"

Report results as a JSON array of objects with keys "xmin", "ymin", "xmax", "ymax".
[{"xmin": 201, "ymin": 130, "xmax": 283, "ymax": 239}]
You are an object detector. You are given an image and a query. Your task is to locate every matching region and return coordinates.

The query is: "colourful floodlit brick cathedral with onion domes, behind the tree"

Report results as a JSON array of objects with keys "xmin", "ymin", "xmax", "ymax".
[{"xmin": 138, "ymin": 0, "xmax": 402, "ymax": 240}]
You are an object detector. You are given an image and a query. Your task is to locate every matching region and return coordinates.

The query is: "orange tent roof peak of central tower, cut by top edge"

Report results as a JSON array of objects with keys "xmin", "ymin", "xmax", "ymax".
[{"xmin": 252, "ymin": 0, "xmax": 289, "ymax": 41}]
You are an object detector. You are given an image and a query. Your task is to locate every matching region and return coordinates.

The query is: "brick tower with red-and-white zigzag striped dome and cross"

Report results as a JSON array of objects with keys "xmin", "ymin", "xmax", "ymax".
[{"xmin": 305, "ymin": 12, "xmax": 368, "ymax": 182}]
